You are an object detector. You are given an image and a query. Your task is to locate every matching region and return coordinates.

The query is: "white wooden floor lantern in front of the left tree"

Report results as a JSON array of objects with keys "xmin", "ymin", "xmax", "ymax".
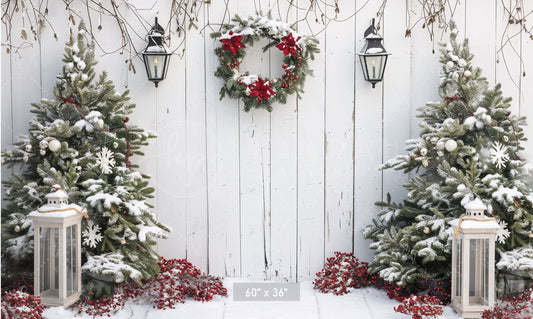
[{"xmin": 28, "ymin": 185, "xmax": 86, "ymax": 307}]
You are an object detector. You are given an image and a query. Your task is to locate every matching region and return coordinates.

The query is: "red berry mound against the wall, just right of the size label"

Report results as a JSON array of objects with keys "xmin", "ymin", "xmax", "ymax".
[{"xmin": 313, "ymin": 251, "xmax": 377, "ymax": 295}]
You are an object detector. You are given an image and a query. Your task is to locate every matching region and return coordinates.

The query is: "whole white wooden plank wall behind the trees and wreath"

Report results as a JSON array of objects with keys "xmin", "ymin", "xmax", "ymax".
[{"xmin": 1, "ymin": 0, "xmax": 533, "ymax": 281}]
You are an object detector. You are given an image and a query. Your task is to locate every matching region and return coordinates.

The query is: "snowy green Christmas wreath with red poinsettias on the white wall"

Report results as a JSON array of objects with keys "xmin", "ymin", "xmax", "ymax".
[{"xmin": 211, "ymin": 16, "xmax": 319, "ymax": 112}]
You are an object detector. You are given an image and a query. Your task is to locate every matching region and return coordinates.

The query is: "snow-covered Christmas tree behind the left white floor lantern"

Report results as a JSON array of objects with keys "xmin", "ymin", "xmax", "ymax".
[{"xmin": 2, "ymin": 23, "xmax": 170, "ymax": 297}]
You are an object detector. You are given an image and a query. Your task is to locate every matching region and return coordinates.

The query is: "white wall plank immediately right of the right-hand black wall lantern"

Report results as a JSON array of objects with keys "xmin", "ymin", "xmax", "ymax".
[{"xmin": 382, "ymin": 1, "xmax": 411, "ymax": 201}]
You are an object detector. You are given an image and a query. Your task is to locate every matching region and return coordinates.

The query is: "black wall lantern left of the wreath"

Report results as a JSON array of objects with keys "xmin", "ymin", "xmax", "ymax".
[{"xmin": 141, "ymin": 17, "xmax": 171, "ymax": 87}]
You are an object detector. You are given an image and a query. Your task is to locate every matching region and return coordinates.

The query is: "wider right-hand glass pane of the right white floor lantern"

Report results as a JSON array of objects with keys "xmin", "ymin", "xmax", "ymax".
[{"xmin": 468, "ymin": 238, "xmax": 489, "ymax": 306}]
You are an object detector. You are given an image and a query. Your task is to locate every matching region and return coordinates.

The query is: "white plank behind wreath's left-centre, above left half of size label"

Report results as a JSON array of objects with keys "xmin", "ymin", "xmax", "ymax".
[{"xmin": 239, "ymin": 0, "xmax": 270, "ymax": 279}]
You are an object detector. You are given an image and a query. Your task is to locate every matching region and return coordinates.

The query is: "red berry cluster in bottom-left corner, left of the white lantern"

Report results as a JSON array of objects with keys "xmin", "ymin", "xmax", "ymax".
[{"xmin": 0, "ymin": 289, "xmax": 46, "ymax": 319}]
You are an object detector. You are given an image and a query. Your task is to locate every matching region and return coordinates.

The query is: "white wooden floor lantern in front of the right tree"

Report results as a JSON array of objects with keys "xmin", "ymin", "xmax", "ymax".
[{"xmin": 452, "ymin": 198, "xmax": 499, "ymax": 318}]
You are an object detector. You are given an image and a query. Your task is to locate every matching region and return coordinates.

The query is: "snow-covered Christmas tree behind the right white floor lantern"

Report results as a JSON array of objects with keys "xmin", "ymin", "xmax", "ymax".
[{"xmin": 364, "ymin": 23, "xmax": 533, "ymax": 286}]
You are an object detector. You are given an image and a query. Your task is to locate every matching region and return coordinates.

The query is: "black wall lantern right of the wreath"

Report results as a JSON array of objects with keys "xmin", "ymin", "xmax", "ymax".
[{"xmin": 358, "ymin": 19, "xmax": 389, "ymax": 88}]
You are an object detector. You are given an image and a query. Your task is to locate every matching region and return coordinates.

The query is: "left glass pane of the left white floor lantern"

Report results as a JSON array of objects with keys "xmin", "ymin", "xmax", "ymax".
[{"xmin": 39, "ymin": 227, "xmax": 59, "ymax": 298}]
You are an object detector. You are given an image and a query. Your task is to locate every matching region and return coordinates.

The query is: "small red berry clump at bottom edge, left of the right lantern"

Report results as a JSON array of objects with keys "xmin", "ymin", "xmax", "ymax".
[{"xmin": 394, "ymin": 295, "xmax": 443, "ymax": 319}]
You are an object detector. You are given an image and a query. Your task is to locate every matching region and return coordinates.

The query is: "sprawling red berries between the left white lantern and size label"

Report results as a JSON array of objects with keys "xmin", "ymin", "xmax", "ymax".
[{"xmin": 73, "ymin": 258, "xmax": 228, "ymax": 317}]
